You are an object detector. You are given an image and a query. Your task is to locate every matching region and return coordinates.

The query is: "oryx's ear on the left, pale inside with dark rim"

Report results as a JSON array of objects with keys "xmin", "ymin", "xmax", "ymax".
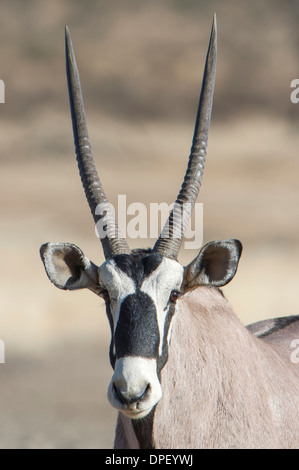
[{"xmin": 40, "ymin": 243, "xmax": 100, "ymax": 292}]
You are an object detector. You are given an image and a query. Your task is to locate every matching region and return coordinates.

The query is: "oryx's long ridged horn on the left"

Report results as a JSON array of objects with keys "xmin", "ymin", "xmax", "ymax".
[{"xmin": 65, "ymin": 26, "xmax": 130, "ymax": 259}]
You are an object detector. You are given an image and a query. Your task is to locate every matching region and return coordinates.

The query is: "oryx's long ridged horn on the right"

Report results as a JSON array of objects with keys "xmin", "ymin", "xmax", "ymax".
[{"xmin": 153, "ymin": 15, "xmax": 217, "ymax": 259}]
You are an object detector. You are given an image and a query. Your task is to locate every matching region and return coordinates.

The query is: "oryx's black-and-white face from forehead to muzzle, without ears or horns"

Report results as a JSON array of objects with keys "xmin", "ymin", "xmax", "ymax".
[{"xmin": 99, "ymin": 252, "xmax": 184, "ymax": 418}]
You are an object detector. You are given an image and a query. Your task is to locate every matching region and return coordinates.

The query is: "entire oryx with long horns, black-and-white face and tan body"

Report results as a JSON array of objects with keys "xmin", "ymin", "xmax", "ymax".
[{"xmin": 41, "ymin": 19, "xmax": 299, "ymax": 448}]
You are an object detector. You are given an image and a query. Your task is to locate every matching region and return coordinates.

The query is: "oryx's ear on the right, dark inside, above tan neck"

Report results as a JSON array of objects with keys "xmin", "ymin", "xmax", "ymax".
[{"xmin": 182, "ymin": 239, "xmax": 242, "ymax": 291}]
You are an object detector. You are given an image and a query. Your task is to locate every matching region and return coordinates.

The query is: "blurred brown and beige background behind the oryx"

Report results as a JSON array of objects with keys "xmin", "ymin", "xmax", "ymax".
[{"xmin": 0, "ymin": 0, "xmax": 299, "ymax": 448}]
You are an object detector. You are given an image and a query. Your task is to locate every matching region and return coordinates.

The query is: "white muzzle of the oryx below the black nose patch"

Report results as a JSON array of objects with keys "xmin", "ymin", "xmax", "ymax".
[{"xmin": 107, "ymin": 357, "xmax": 162, "ymax": 419}]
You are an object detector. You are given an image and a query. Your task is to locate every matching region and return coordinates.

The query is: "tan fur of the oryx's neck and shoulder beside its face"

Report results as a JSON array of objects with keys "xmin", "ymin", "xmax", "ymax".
[{"xmin": 153, "ymin": 287, "xmax": 299, "ymax": 449}]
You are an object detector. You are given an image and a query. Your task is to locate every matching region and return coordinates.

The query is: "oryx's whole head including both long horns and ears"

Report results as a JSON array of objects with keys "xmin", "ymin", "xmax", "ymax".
[{"xmin": 41, "ymin": 19, "xmax": 241, "ymax": 418}]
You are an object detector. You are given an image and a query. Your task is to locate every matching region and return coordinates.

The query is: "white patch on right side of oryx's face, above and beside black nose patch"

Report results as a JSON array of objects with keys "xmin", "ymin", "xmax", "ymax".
[{"xmin": 140, "ymin": 258, "xmax": 184, "ymax": 355}]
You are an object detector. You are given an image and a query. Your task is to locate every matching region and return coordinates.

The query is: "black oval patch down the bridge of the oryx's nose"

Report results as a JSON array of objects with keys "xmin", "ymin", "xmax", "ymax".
[{"xmin": 114, "ymin": 291, "xmax": 160, "ymax": 359}]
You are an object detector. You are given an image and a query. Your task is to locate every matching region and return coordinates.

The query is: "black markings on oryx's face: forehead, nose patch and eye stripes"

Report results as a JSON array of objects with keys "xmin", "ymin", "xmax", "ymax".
[{"xmin": 106, "ymin": 249, "xmax": 179, "ymax": 375}]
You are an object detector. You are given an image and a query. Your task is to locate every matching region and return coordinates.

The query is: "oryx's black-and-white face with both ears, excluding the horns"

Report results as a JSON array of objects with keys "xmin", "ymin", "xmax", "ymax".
[{"xmin": 41, "ymin": 240, "xmax": 242, "ymax": 418}]
